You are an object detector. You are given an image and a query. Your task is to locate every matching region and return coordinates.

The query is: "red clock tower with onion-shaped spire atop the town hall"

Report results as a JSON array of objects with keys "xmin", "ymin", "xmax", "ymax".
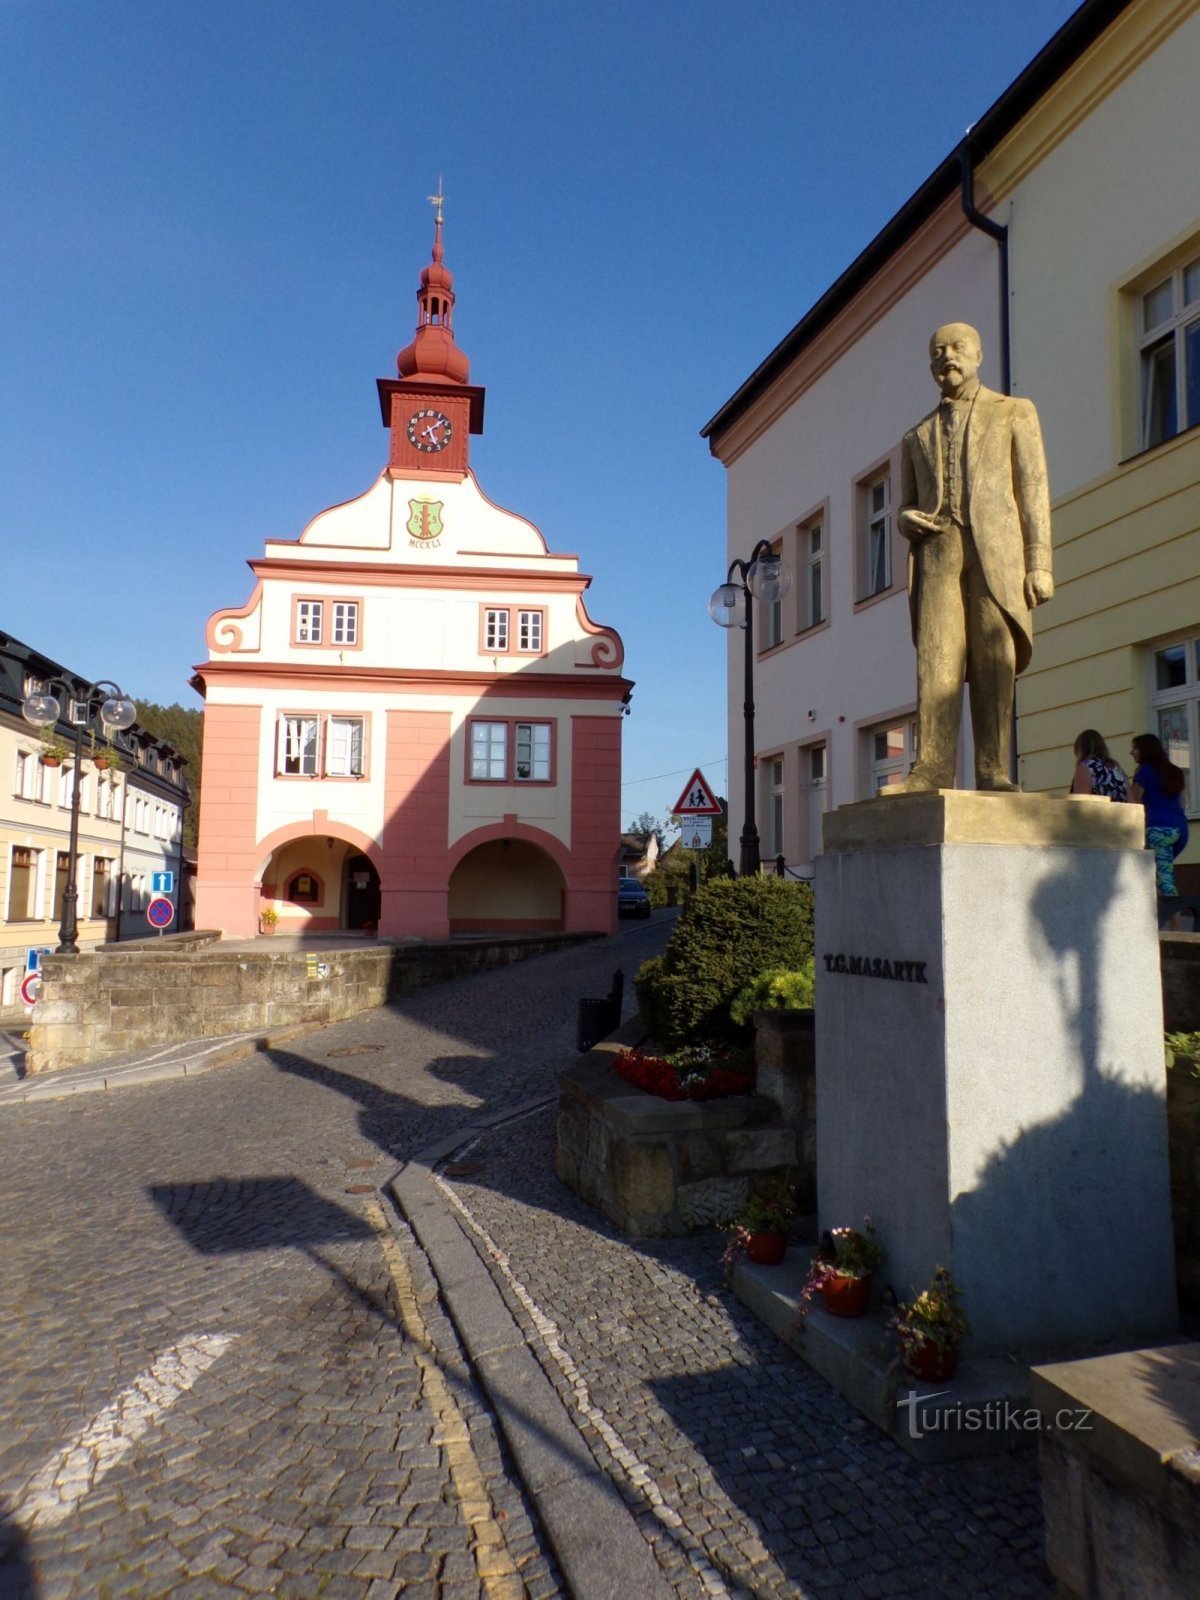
[{"xmin": 378, "ymin": 189, "xmax": 483, "ymax": 478}]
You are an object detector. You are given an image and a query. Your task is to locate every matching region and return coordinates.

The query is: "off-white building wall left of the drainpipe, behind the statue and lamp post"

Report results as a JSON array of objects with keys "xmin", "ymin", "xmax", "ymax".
[{"xmin": 722, "ymin": 202, "xmax": 998, "ymax": 870}]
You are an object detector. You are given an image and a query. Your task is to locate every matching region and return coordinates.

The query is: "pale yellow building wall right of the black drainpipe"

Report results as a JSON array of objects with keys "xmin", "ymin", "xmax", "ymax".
[{"xmin": 986, "ymin": 0, "xmax": 1200, "ymax": 861}]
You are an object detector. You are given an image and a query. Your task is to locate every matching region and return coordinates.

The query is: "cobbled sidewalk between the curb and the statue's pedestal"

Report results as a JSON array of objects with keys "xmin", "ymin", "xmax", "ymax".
[{"xmin": 442, "ymin": 1110, "xmax": 1054, "ymax": 1600}]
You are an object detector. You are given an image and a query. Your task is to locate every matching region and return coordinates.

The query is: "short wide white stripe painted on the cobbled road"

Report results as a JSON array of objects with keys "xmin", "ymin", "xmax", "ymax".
[{"xmin": 13, "ymin": 1333, "xmax": 237, "ymax": 1530}]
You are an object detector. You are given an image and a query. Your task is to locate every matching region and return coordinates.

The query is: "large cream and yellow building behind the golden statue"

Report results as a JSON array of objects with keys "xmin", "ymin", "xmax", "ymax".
[{"xmin": 704, "ymin": 0, "xmax": 1200, "ymax": 874}]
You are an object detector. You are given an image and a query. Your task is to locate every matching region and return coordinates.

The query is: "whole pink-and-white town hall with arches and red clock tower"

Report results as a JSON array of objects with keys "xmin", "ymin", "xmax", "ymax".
[{"xmin": 194, "ymin": 211, "xmax": 632, "ymax": 939}]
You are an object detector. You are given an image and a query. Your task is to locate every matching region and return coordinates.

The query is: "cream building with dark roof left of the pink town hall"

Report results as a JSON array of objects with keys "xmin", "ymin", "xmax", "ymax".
[{"xmin": 0, "ymin": 635, "xmax": 189, "ymax": 1013}]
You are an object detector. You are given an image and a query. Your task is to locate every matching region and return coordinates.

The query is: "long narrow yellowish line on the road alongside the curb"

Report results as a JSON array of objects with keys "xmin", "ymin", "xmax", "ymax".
[{"xmin": 363, "ymin": 1200, "xmax": 526, "ymax": 1600}]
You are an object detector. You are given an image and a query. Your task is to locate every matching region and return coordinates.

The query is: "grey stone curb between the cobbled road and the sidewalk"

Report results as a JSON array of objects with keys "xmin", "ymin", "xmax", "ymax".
[{"xmin": 389, "ymin": 1018, "xmax": 674, "ymax": 1600}]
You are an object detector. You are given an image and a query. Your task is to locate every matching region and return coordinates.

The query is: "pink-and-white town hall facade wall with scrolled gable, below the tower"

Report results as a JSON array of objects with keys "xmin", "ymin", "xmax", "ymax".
[{"xmin": 197, "ymin": 457, "xmax": 630, "ymax": 938}]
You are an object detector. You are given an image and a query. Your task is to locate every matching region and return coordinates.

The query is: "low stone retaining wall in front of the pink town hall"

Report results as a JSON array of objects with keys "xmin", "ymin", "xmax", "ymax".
[{"xmin": 34, "ymin": 934, "xmax": 592, "ymax": 1074}]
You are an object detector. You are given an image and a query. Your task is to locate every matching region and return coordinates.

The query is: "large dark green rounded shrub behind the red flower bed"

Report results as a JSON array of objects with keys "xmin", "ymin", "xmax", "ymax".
[{"xmin": 635, "ymin": 877, "xmax": 813, "ymax": 1048}]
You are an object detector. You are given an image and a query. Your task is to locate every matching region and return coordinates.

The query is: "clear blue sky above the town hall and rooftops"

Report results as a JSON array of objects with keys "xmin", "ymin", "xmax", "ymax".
[{"xmin": 0, "ymin": 0, "xmax": 1074, "ymax": 822}]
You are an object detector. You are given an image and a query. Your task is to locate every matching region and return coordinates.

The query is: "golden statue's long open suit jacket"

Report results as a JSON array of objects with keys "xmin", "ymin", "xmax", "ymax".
[{"xmin": 901, "ymin": 386, "xmax": 1051, "ymax": 672}]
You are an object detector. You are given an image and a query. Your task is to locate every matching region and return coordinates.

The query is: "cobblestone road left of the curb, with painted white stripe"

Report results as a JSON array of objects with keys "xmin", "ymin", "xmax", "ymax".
[{"xmin": 0, "ymin": 917, "xmax": 666, "ymax": 1600}]
